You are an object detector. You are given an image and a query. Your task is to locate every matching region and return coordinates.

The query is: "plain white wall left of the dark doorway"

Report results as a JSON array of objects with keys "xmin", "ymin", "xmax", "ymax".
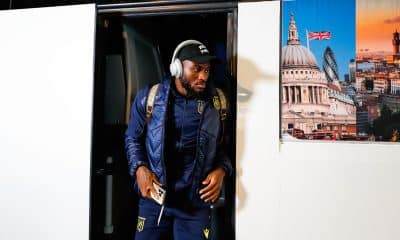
[{"xmin": 0, "ymin": 5, "xmax": 95, "ymax": 240}]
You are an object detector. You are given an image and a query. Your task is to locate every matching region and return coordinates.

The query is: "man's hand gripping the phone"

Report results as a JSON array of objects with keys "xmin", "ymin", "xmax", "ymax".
[{"xmin": 136, "ymin": 166, "xmax": 162, "ymax": 199}]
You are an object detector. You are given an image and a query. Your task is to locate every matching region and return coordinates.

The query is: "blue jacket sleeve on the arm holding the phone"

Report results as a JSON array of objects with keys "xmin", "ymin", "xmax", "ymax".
[{"xmin": 125, "ymin": 87, "xmax": 149, "ymax": 178}]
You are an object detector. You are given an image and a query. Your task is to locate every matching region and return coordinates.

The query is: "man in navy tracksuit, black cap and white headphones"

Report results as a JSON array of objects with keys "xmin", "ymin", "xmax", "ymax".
[{"xmin": 125, "ymin": 40, "xmax": 232, "ymax": 240}]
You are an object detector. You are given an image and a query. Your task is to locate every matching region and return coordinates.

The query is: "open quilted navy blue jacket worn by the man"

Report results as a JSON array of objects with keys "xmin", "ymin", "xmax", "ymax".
[{"xmin": 125, "ymin": 78, "xmax": 232, "ymax": 206}]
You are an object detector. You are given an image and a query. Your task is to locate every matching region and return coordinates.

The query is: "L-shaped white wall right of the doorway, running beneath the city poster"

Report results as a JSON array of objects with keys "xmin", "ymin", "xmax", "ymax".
[{"xmin": 236, "ymin": 1, "xmax": 400, "ymax": 240}]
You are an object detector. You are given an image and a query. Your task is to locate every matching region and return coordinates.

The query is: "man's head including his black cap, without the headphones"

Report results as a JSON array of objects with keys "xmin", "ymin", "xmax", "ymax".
[{"xmin": 170, "ymin": 43, "xmax": 217, "ymax": 96}]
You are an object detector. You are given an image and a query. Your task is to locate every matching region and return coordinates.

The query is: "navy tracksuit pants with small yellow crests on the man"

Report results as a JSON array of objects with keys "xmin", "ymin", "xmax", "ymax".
[{"xmin": 135, "ymin": 198, "xmax": 212, "ymax": 240}]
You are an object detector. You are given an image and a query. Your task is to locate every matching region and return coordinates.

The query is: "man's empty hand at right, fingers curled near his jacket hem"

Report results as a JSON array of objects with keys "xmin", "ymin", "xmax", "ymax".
[{"xmin": 199, "ymin": 167, "xmax": 225, "ymax": 202}]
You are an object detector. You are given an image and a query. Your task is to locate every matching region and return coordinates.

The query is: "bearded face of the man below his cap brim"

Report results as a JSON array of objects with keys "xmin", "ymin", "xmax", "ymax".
[{"xmin": 181, "ymin": 60, "xmax": 210, "ymax": 95}]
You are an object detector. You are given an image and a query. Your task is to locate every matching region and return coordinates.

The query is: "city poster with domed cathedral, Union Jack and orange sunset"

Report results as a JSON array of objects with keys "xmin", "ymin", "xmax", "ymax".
[{"xmin": 281, "ymin": 0, "xmax": 400, "ymax": 142}]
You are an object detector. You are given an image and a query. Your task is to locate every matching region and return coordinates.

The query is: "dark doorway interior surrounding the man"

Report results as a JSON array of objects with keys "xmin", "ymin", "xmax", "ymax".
[{"xmin": 90, "ymin": 5, "xmax": 236, "ymax": 240}]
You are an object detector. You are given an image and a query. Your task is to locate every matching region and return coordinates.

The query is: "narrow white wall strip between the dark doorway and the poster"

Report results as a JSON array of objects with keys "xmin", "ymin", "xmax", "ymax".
[{"xmin": 236, "ymin": 1, "xmax": 279, "ymax": 240}]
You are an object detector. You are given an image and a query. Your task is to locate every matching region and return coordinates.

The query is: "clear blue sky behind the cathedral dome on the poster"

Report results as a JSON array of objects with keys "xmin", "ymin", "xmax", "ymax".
[{"xmin": 282, "ymin": 0, "xmax": 356, "ymax": 80}]
